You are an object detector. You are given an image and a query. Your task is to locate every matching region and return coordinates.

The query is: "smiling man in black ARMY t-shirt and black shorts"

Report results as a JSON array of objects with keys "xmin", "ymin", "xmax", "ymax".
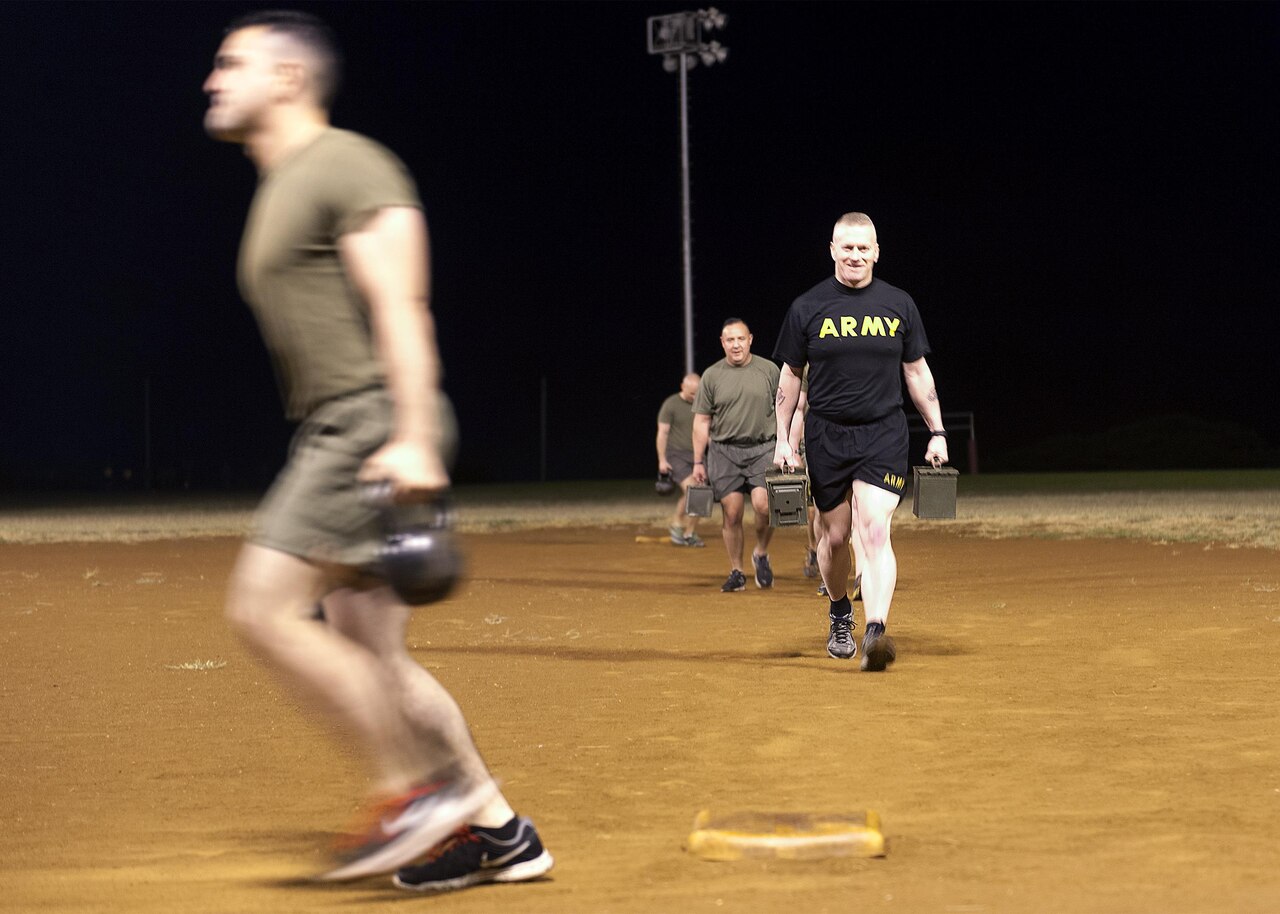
[{"xmin": 773, "ymin": 212, "xmax": 947, "ymax": 671}]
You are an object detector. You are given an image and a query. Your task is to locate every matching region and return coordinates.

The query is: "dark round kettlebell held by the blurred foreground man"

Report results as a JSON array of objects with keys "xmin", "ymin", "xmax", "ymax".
[{"xmin": 365, "ymin": 483, "xmax": 463, "ymax": 605}]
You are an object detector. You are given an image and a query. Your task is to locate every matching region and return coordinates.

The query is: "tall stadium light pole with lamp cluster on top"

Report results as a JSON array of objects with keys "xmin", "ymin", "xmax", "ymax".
[{"xmin": 648, "ymin": 6, "xmax": 728, "ymax": 374}]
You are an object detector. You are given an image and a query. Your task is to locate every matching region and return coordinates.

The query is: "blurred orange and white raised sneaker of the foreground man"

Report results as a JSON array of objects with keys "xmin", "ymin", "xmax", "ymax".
[{"xmin": 319, "ymin": 781, "xmax": 498, "ymax": 882}]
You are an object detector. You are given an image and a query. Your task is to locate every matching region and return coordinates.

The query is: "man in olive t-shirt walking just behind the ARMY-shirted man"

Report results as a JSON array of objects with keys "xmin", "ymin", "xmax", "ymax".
[{"xmin": 694, "ymin": 317, "xmax": 778, "ymax": 593}]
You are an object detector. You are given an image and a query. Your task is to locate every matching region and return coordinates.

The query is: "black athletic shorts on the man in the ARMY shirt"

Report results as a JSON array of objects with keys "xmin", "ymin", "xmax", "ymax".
[{"xmin": 804, "ymin": 410, "xmax": 908, "ymax": 511}]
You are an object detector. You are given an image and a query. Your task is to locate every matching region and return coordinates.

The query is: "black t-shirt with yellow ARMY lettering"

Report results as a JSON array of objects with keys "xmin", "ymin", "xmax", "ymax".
[{"xmin": 773, "ymin": 277, "xmax": 929, "ymax": 425}]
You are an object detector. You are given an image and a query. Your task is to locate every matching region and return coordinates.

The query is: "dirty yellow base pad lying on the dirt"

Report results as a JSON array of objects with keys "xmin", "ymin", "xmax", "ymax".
[{"xmin": 685, "ymin": 809, "xmax": 884, "ymax": 860}]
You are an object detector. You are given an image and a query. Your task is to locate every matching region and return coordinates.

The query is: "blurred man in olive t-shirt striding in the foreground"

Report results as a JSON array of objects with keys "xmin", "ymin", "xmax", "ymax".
[{"xmin": 205, "ymin": 12, "xmax": 552, "ymax": 890}]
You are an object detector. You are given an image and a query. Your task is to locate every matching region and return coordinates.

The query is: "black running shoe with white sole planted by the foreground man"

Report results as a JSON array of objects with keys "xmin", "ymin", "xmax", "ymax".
[{"xmin": 392, "ymin": 815, "xmax": 554, "ymax": 892}]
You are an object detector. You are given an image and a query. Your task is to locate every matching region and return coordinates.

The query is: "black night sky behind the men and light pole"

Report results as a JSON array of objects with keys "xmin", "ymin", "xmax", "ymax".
[{"xmin": 0, "ymin": 0, "xmax": 1280, "ymax": 489}]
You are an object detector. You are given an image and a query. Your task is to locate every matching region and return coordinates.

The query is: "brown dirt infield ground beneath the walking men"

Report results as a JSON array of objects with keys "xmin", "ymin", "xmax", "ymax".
[{"xmin": 0, "ymin": 525, "xmax": 1280, "ymax": 914}]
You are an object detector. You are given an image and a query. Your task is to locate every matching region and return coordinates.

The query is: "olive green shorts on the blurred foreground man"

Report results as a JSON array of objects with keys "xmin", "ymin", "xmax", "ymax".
[{"xmin": 250, "ymin": 388, "xmax": 457, "ymax": 567}]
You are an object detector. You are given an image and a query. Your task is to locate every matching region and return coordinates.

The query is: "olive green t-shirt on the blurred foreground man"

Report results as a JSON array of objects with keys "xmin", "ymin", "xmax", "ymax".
[{"xmin": 238, "ymin": 128, "xmax": 421, "ymax": 419}]
